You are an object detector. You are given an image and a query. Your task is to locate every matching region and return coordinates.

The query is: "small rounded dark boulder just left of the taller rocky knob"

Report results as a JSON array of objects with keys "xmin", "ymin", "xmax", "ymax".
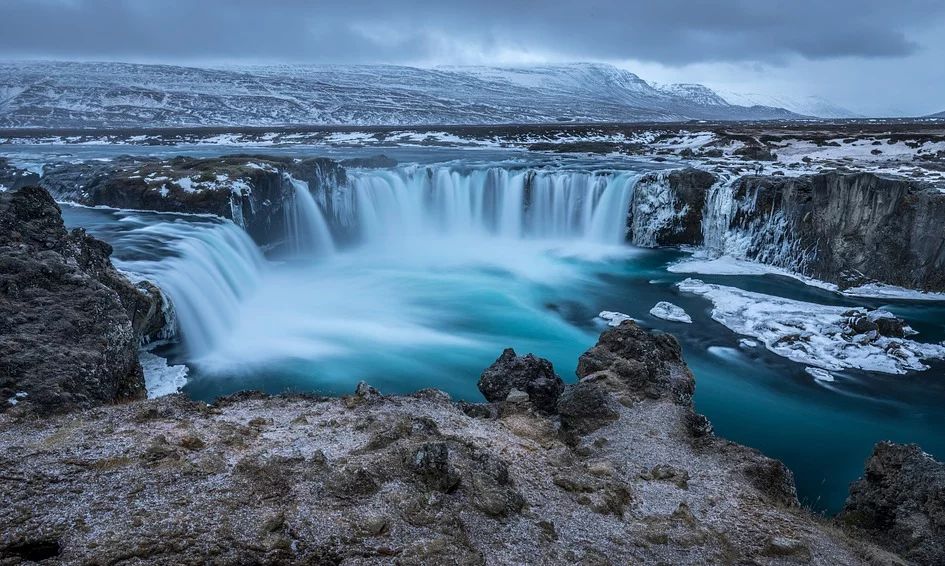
[{"xmin": 479, "ymin": 348, "xmax": 564, "ymax": 413}]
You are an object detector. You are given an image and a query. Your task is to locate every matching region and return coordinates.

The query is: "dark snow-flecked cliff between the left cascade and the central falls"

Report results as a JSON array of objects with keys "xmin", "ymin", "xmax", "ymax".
[{"xmin": 40, "ymin": 156, "xmax": 345, "ymax": 253}]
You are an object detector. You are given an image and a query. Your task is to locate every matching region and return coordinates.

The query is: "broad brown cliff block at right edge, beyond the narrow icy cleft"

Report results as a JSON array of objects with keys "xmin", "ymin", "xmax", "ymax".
[{"xmin": 730, "ymin": 172, "xmax": 945, "ymax": 291}]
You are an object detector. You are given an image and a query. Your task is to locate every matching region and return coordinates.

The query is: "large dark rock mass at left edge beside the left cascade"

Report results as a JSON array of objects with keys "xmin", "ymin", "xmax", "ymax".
[{"xmin": 0, "ymin": 187, "xmax": 163, "ymax": 412}]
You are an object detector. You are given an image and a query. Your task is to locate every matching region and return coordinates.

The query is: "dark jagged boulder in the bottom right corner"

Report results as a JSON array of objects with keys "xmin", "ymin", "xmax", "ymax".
[{"xmin": 840, "ymin": 442, "xmax": 945, "ymax": 565}]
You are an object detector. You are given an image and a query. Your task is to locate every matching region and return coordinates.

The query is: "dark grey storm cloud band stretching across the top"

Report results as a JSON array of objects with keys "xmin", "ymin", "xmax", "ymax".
[{"xmin": 0, "ymin": 0, "xmax": 945, "ymax": 65}]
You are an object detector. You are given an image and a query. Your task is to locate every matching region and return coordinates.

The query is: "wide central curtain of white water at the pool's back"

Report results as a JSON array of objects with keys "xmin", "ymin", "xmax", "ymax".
[{"xmin": 330, "ymin": 166, "xmax": 639, "ymax": 244}]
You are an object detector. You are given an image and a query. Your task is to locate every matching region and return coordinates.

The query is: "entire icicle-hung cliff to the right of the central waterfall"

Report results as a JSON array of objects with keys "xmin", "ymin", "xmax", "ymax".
[{"xmin": 628, "ymin": 169, "xmax": 945, "ymax": 291}]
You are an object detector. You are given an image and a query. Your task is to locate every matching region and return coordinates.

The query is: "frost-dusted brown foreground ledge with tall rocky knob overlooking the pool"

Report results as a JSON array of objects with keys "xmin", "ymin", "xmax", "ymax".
[{"xmin": 0, "ymin": 322, "xmax": 899, "ymax": 564}]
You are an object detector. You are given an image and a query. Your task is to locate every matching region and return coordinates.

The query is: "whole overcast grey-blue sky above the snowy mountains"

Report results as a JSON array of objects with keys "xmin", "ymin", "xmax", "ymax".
[{"xmin": 0, "ymin": 0, "xmax": 945, "ymax": 115}]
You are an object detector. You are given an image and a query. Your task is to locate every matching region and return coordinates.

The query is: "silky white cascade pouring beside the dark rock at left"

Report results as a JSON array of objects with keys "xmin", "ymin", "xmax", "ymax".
[{"xmin": 116, "ymin": 220, "xmax": 265, "ymax": 357}]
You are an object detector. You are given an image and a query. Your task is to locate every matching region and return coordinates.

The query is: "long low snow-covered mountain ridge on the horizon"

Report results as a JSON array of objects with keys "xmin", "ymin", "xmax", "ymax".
[{"xmin": 0, "ymin": 62, "xmax": 798, "ymax": 128}]
